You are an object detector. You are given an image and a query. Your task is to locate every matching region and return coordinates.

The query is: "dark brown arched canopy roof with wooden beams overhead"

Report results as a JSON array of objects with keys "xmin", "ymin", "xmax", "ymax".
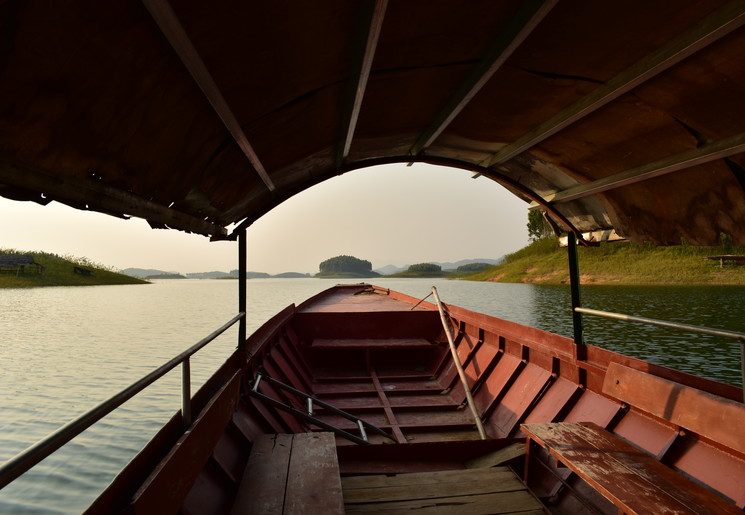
[{"xmin": 0, "ymin": 0, "xmax": 745, "ymax": 244}]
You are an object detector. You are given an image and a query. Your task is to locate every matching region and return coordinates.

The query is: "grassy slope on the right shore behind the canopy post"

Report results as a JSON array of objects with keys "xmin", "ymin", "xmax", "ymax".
[{"xmin": 468, "ymin": 238, "xmax": 745, "ymax": 285}]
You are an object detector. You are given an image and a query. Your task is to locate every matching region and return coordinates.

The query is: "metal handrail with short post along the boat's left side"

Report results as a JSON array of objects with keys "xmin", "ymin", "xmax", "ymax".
[{"xmin": 0, "ymin": 312, "xmax": 246, "ymax": 489}]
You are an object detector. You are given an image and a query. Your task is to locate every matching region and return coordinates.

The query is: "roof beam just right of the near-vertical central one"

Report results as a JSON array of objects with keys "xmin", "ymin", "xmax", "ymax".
[{"xmin": 409, "ymin": 0, "xmax": 559, "ymax": 155}]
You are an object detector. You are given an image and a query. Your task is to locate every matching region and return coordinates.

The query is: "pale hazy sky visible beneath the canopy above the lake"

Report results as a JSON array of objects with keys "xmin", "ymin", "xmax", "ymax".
[{"xmin": 0, "ymin": 164, "xmax": 528, "ymax": 273}]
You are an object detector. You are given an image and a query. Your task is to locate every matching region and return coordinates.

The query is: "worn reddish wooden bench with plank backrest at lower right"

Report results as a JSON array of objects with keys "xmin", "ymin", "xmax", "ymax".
[{"xmin": 522, "ymin": 363, "xmax": 745, "ymax": 514}]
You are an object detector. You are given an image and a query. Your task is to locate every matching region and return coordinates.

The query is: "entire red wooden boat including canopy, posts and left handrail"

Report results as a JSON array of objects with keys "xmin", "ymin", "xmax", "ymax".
[{"xmin": 0, "ymin": 0, "xmax": 745, "ymax": 513}]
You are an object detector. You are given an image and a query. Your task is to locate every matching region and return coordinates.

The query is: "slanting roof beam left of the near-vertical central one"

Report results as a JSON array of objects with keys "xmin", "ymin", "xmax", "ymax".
[{"xmin": 142, "ymin": 0, "xmax": 276, "ymax": 192}]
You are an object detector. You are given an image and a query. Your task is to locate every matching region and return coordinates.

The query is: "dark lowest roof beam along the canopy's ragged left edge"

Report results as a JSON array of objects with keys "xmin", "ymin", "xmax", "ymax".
[{"xmin": 0, "ymin": 162, "xmax": 227, "ymax": 238}]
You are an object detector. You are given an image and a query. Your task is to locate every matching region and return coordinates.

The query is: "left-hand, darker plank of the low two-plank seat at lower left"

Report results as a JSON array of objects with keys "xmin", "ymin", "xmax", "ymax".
[{"xmin": 231, "ymin": 434, "xmax": 292, "ymax": 515}]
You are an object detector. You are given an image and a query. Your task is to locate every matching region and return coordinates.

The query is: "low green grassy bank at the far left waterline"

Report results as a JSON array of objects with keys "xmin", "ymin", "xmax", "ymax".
[{"xmin": 0, "ymin": 250, "xmax": 147, "ymax": 288}]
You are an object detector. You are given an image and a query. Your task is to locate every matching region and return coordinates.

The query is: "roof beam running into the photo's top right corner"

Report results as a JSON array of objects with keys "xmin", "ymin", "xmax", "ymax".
[{"xmin": 480, "ymin": 0, "xmax": 745, "ymax": 168}]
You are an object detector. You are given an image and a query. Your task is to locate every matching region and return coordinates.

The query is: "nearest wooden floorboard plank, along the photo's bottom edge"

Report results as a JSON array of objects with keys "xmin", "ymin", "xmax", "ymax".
[{"xmin": 346, "ymin": 490, "xmax": 544, "ymax": 515}]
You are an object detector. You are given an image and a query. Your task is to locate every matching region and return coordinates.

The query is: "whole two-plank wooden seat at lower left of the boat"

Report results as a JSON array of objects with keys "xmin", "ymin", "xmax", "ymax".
[{"xmin": 231, "ymin": 433, "xmax": 344, "ymax": 515}]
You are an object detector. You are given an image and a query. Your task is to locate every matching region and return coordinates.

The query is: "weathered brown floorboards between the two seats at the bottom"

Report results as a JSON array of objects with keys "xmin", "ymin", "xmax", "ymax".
[{"xmin": 342, "ymin": 467, "xmax": 543, "ymax": 515}]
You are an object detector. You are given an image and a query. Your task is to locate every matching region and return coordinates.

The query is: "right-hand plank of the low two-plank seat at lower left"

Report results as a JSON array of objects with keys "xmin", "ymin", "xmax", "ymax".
[{"xmin": 284, "ymin": 433, "xmax": 344, "ymax": 515}]
